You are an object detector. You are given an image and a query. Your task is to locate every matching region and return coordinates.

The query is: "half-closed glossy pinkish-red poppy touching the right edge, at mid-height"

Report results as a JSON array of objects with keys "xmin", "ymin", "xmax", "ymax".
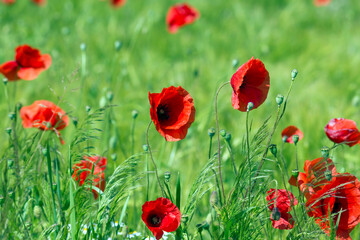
[{"xmin": 325, "ymin": 118, "xmax": 360, "ymax": 147}]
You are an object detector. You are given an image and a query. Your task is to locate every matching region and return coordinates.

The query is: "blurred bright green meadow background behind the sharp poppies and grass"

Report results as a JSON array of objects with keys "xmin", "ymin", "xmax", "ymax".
[{"xmin": 0, "ymin": 0, "xmax": 360, "ymax": 238}]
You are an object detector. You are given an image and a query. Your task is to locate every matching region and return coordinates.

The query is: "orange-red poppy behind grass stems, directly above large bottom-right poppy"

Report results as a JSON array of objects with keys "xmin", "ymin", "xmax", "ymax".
[{"xmin": 289, "ymin": 157, "xmax": 337, "ymax": 199}]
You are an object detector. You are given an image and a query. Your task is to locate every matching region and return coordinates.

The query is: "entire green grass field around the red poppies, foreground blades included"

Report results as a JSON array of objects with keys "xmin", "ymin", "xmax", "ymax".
[{"xmin": 0, "ymin": 0, "xmax": 360, "ymax": 239}]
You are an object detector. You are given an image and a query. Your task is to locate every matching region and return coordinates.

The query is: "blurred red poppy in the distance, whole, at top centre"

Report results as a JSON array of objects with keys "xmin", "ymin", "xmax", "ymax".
[{"xmin": 166, "ymin": 3, "xmax": 200, "ymax": 33}]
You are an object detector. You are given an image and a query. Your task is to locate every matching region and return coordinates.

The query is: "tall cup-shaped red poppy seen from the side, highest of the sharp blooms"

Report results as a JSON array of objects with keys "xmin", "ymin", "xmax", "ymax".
[{"xmin": 231, "ymin": 57, "xmax": 270, "ymax": 112}]
